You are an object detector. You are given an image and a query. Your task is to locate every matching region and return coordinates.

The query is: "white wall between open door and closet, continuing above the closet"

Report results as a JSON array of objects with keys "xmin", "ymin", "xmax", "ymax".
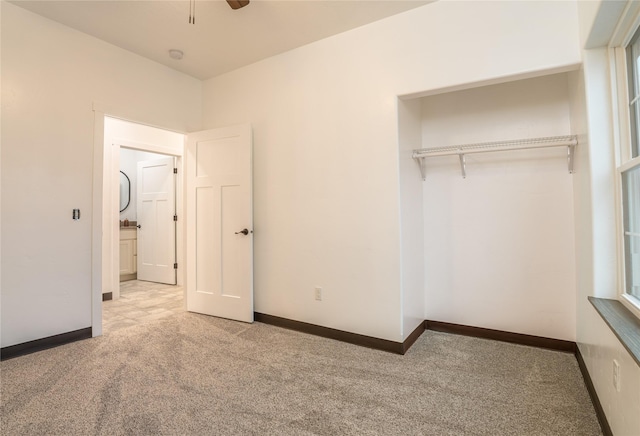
[{"xmin": 204, "ymin": 1, "xmax": 580, "ymax": 341}]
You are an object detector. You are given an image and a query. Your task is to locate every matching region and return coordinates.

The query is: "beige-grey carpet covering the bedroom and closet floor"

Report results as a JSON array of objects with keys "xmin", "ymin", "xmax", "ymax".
[{"xmin": 0, "ymin": 312, "xmax": 601, "ymax": 436}]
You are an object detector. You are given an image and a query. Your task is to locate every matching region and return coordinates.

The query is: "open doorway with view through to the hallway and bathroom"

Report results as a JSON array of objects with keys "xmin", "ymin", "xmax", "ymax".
[{"xmin": 102, "ymin": 117, "xmax": 185, "ymax": 333}]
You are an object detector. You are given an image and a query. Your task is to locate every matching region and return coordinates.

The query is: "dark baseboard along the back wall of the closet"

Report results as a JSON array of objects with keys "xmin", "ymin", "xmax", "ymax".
[{"xmin": 425, "ymin": 320, "xmax": 577, "ymax": 353}]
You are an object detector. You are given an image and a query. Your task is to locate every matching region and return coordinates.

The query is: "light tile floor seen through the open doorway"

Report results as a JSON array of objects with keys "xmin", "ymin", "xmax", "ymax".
[{"xmin": 102, "ymin": 280, "xmax": 184, "ymax": 334}]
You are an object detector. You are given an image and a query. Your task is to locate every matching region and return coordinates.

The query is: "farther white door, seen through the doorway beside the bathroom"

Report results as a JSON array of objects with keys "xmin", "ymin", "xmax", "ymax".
[{"xmin": 136, "ymin": 157, "xmax": 176, "ymax": 285}]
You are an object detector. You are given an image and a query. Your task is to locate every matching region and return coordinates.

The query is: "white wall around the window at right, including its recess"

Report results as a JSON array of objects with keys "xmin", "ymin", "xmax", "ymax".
[{"xmin": 570, "ymin": 2, "xmax": 640, "ymax": 435}]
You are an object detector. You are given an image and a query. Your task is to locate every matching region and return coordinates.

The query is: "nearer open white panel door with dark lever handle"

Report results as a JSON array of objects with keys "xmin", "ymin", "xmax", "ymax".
[{"xmin": 185, "ymin": 125, "xmax": 253, "ymax": 322}]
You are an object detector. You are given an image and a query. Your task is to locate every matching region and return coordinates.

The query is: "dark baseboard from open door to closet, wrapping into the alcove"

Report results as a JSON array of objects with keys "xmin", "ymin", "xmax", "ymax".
[{"xmin": 254, "ymin": 312, "xmax": 424, "ymax": 354}]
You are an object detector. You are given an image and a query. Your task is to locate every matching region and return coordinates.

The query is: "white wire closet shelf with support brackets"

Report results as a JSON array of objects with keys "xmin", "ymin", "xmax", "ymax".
[{"xmin": 413, "ymin": 135, "xmax": 578, "ymax": 180}]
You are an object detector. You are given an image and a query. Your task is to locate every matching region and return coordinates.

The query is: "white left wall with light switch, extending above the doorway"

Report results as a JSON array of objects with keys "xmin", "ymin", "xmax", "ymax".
[{"xmin": 1, "ymin": 1, "xmax": 202, "ymax": 347}]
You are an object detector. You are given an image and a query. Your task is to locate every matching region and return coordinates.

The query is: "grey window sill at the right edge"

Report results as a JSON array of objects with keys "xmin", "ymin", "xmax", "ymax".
[{"xmin": 589, "ymin": 297, "xmax": 640, "ymax": 366}]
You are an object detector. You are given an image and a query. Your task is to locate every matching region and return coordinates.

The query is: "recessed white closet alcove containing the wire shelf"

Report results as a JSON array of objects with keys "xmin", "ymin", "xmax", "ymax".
[{"xmin": 398, "ymin": 72, "xmax": 584, "ymax": 340}]
